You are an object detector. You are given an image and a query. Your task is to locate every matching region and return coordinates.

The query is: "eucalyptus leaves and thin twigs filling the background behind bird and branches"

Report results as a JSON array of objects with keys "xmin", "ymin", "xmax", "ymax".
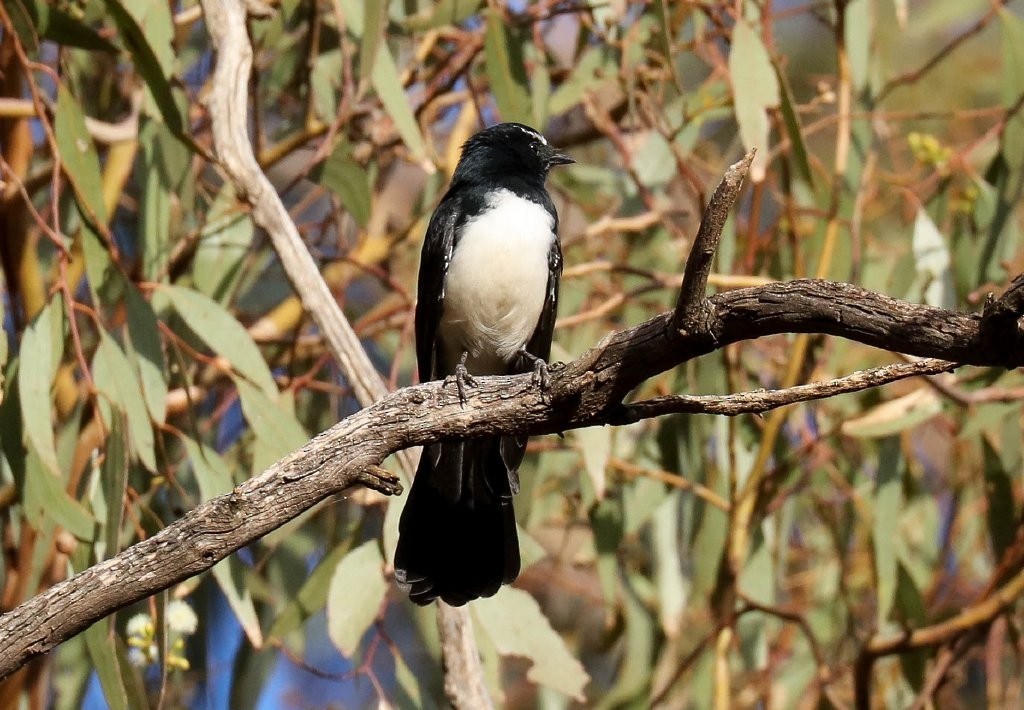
[{"xmin": 0, "ymin": 0, "xmax": 1024, "ymax": 708}]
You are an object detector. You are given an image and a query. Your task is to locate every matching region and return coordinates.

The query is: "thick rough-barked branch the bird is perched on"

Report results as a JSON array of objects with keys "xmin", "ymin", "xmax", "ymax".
[{"xmin": 0, "ymin": 266, "xmax": 1024, "ymax": 676}]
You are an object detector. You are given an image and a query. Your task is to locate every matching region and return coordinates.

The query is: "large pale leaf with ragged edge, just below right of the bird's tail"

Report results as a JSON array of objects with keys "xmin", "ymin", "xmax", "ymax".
[{"xmin": 472, "ymin": 587, "xmax": 590, "ymax": 703}]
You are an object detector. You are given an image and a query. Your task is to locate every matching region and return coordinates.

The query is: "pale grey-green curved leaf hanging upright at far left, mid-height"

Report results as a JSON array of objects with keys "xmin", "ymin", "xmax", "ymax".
[{"xmin": 17, "ymin": 295, "xmax": 63, "ymax": 475}]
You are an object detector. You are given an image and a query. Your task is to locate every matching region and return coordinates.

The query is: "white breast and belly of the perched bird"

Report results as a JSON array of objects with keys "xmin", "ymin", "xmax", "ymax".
[{"xmin": 438, "ymin": 190, "xmax": 555, "ymax": 375}]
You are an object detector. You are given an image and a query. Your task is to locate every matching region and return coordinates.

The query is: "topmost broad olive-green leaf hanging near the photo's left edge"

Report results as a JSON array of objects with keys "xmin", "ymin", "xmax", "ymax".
[{"xmin": 53, "ymin": 82, "xmax": 106, "ymax": 232}]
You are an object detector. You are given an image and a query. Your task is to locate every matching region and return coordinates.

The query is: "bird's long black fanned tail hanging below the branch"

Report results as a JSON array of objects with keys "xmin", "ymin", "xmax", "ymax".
[{"xmin": 394, "ymin": 438, "xmax": 521, "ymax": 607}]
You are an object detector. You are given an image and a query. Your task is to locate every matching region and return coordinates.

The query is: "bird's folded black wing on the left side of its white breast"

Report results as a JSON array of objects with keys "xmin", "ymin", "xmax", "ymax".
[{"xmin": 416, "ymin": 198, "xmax": 460, "ymax": 382}]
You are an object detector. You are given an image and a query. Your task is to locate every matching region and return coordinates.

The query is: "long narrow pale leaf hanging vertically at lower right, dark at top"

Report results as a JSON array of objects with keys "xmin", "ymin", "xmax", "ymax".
[{"xmin": 871, "ymin": 436, "xmax": 903, "ymax": 627}]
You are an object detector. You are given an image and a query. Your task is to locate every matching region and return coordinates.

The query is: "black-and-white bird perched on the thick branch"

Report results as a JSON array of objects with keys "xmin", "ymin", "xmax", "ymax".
[{"xmin": 394, "ymin": 123, "xmax": 575, "ymax": 607}]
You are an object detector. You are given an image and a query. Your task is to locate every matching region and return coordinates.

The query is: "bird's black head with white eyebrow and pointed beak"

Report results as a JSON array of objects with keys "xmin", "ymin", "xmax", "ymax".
[{"xmin": 453, "ymin": 123, "xmax": 575, "ymax": 183}]
